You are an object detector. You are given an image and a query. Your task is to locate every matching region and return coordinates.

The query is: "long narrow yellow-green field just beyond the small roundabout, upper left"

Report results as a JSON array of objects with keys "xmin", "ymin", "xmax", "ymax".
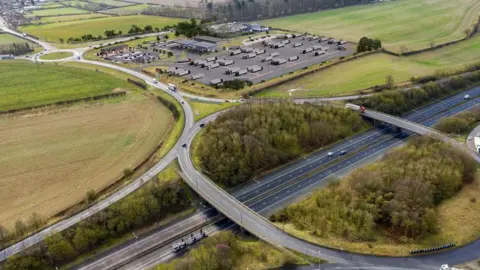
[{"xmin": 20, "ymin": 15, "xmax": 184, "ymax": 42}]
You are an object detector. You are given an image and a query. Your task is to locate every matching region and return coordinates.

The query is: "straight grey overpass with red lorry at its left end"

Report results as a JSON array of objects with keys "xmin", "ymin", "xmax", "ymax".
[{"xmin": 346, "ymin": 103, "xmax": 480, "ymax": 163}]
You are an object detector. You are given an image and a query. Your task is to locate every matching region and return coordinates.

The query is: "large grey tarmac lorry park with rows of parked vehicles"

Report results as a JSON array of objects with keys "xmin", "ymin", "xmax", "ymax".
[{"xmin": 169, "ymin": 34, "xmax": 354, "ymax": 87}]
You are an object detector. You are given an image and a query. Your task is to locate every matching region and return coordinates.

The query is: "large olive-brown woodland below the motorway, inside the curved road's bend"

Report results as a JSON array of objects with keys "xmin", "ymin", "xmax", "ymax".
[{"xmin": 271, "ymin": 137, "xmax": 478, "ymax": 241}]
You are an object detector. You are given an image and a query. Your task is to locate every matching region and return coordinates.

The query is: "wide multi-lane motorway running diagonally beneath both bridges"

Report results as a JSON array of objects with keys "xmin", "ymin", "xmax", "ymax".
[{"xmin": 79, "ymin": 88, "xmax": 480, "ymax": 269}]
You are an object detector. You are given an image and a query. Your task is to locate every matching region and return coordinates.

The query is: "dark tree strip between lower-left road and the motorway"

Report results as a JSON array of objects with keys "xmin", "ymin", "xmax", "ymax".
[{"xmin": 3, "ymin": 175, "xmax": 190, "ymax": 270}]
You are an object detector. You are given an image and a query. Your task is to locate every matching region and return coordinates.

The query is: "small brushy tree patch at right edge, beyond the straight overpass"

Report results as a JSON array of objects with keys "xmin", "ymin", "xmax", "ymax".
[{"xmin": 435, "ymin": 107, "xmax": 480, "ymax": 134}]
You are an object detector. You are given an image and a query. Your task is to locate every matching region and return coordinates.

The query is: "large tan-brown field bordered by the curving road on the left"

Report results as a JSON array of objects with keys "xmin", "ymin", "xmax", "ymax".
[{"xmin": 0, "ymin": 93, "xmax": 170, "ymax": 227}]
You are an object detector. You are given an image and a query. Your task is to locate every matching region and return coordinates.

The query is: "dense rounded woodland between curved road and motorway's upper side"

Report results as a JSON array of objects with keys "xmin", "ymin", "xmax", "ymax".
[{"xmin": 195, "ymin": 101, "xmax": 364, "ymax": 187}]
